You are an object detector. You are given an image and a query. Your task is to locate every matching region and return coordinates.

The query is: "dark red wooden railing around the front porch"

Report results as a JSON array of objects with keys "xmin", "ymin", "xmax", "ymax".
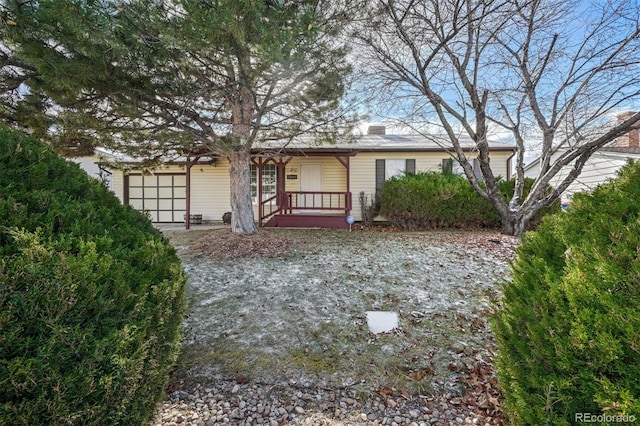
[{"xmin": 260, "ymin": 191, "xmax": 352, "ymax": 223}]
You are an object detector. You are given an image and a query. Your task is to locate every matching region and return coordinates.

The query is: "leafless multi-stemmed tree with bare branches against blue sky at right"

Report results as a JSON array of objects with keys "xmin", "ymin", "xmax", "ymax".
[{"xmin": 354, "ymin": 0, "xmax": 640, "ymax": 235}]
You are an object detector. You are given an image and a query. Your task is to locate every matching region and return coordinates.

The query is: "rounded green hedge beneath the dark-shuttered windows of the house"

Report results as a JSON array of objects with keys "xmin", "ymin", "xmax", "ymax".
[{"xmin": 380, "ymin": 172, "xmax": 560, "ymax": 228}]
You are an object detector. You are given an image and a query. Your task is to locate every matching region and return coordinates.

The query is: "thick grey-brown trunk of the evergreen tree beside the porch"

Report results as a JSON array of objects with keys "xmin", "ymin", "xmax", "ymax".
[{"xmin": 227, "ymin": 150, "xmax": 258, "ymax": 235}]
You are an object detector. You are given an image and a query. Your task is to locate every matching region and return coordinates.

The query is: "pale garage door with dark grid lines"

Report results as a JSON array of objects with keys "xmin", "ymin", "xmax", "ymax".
[{"xmin": 125, "ymin": 173, "xmax": 187, "ymax": 222}]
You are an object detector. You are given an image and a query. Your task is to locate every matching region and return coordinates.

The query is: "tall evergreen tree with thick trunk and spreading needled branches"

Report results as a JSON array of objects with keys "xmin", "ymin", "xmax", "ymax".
[{"xmin": 2, "ymin": 0, "xmax": 350, "ymax": 234}]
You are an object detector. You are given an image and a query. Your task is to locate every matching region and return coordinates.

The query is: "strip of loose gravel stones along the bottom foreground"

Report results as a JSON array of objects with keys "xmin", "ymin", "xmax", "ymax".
[{"xmin": 152, "ymin": 380, "xmax": 502, "ymax": 426}]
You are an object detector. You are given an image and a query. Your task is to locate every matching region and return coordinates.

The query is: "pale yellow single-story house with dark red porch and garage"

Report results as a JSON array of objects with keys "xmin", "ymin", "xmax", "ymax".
[{"xmin": 104, "ymin": 126, "xmax": 514, "ymax": 228}]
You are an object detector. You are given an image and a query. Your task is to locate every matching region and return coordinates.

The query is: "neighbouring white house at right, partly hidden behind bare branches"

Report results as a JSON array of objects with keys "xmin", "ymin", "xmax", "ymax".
[{"xmin": 525, "ymin": 115, "xmax": 640, "ymax": 204}]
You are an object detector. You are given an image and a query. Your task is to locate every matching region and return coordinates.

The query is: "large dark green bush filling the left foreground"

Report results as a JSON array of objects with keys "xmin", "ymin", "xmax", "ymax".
[{"xmin": 0, "ymin": 129, "xmax": 185, "ymax": 425}]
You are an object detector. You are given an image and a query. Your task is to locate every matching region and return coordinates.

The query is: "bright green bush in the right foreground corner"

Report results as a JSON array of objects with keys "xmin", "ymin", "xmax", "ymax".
[{"xmin": 493, "ymin": 163, "xmax": 640, "ymax": 425}]
